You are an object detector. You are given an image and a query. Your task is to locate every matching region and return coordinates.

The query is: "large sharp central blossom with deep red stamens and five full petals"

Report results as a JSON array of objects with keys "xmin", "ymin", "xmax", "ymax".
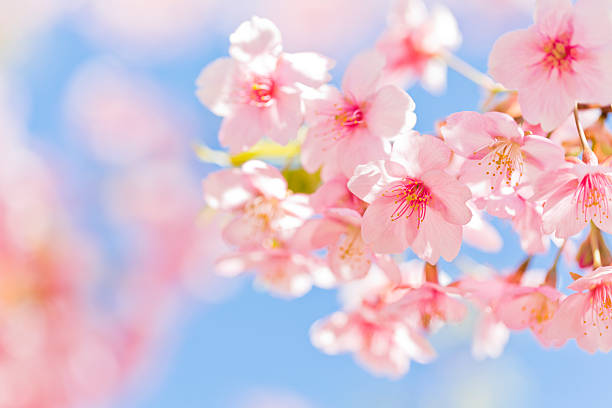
[{"xmin": 349, "ymin": 133, "xmax": 472, "ymax": 263}]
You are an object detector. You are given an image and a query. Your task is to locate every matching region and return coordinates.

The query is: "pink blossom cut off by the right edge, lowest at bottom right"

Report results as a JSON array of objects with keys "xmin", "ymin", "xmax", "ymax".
[{"xmin": 548, "ymin": 266, "xmax": 612, "ymax": 353}]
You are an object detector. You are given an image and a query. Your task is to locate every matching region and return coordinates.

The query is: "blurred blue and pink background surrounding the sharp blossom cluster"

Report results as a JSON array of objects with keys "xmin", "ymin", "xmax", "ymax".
[{"xmin": 0, "ymin": 0, "xmax": 612, "ymax": 408}]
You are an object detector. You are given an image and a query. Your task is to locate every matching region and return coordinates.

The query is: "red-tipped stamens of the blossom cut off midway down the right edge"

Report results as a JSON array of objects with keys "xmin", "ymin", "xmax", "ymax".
[{"xmin": 574, "ymin": 173, "xmax": 612, "ymax": 222}]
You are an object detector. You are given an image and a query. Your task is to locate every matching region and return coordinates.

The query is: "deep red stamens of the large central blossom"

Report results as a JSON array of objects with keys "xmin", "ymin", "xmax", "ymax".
[{"xmin": 383, "ymin": 177, "xmax": 431, "ymax": 228}]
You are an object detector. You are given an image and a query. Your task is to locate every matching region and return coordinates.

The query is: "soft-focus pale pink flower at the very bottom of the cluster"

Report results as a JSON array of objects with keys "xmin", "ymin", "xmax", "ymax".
[{"xmin": 310, "ymin": 303, "xmax": 435, "ymax": 378}]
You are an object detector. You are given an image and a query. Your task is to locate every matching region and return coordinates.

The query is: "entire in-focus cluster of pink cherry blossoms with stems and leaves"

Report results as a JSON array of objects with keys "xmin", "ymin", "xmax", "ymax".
[{"xmin": 197, "ymin": 0, "xmax": 612, "ymax": 377}]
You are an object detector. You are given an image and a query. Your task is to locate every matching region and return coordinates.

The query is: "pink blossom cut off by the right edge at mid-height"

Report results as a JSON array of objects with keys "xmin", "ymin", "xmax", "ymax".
[{"xmin": 534, "ymin": 153, "xmax": 612, "ymax": 238}]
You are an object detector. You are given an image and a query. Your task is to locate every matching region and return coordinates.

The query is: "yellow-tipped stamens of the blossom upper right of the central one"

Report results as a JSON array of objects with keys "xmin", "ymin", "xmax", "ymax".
[{"xmin": 478, "ymin": 140, "xmax": 524, "ymax": 190}]
